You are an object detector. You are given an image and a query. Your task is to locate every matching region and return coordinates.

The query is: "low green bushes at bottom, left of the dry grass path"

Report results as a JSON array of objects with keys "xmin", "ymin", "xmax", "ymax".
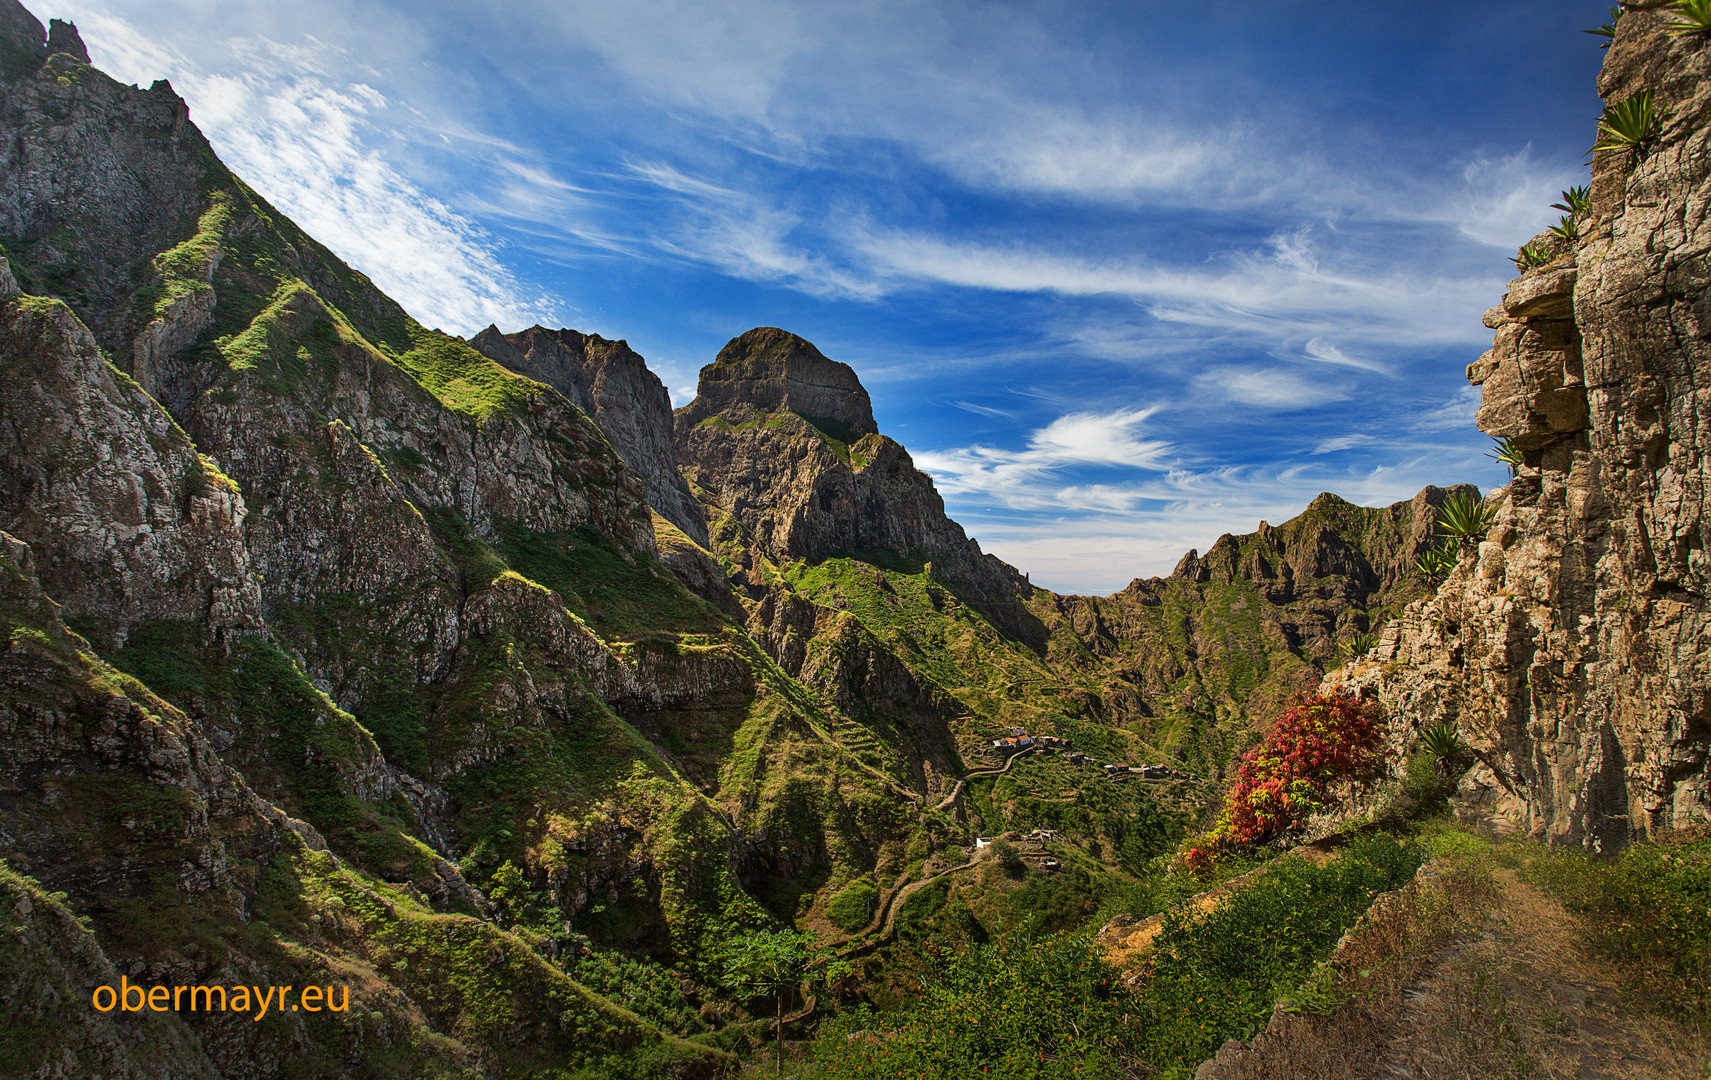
[{"xmin": 814, "ymin": 835, "xmax": 1425, "ymax": 1080}]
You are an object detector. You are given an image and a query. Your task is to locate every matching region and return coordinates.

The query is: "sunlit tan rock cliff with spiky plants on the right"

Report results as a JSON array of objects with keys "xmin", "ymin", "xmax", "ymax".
[{"xmin": 1333, "ymin": 3, "xmax": 1711, "ymax": 849}]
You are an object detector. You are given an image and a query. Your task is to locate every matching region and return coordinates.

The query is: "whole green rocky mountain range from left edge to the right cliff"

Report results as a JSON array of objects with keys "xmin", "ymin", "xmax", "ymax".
[{"xmin": 0, "ymin": 0, "xmax": 1498, "ymax": 1077}]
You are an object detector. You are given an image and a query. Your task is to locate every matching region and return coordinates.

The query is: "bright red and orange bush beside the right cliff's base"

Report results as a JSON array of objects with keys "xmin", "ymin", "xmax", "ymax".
[{"xmin": 1186, "ymin": 691, "xmax": 1384, "ymax": 873}]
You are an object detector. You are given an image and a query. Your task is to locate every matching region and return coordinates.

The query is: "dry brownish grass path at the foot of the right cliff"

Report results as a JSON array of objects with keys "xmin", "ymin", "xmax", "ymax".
[{"xmin": 1218, "ymin": 831, "xmax": 1711, "ymax": 1080}]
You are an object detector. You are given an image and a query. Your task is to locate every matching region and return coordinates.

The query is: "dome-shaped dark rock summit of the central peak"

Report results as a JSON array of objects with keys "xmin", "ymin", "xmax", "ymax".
[{"xmin": 678, "ymin": 327, "xmax": 879, "ymax": 442}]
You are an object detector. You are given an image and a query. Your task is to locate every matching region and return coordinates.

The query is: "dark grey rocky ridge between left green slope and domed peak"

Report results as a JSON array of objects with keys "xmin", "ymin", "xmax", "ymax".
[{"xmin": 469, "ymin": 325, "xmax": 707, "ymax": 548}]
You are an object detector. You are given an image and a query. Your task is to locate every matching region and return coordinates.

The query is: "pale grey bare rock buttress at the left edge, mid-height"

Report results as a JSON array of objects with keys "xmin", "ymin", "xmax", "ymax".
[{"xmin": 0, "ymin": 296, "xmax": 262, "ymax": 645}]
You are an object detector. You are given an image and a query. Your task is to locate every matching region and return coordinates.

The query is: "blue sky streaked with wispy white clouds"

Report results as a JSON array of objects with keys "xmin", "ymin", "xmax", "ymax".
[{"xmin": 53, "ymin": 0, "xmax": 1605, "ymax": 592}]
